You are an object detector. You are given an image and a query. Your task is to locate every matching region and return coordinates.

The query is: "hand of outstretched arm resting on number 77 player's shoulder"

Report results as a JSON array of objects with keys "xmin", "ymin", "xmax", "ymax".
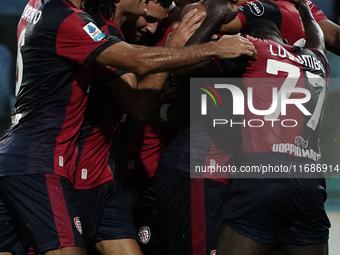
[{"xmin": 215, "ymin": 34, "xmax": 257, "ymax": 59}]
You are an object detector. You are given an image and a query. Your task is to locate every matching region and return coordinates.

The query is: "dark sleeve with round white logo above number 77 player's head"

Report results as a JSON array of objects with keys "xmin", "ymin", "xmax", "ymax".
[{"xmin": 237, "ymin": 1, "xmax": 282, "ymax": 28}]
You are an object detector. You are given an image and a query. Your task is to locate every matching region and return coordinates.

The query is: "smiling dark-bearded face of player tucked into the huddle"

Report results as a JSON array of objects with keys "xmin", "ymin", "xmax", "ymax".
[{"xmin": 122, "ymin": 0, "xmax": 172, "ymax": 43}]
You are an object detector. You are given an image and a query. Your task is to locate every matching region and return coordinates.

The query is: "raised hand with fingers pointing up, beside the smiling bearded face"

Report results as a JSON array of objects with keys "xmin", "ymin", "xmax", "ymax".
[{"xmin": 165, "ymin": 6, "xmax": 207, "ymax": 46}]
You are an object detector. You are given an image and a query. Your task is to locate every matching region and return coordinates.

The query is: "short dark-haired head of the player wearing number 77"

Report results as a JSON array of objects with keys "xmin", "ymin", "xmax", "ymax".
[{"xmin": 241, "ymin": 19, "xmax": 283, "ymax": 43}]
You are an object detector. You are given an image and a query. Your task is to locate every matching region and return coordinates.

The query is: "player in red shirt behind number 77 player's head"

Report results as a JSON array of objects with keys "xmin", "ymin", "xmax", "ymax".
[{"xmin": 221, "ymin": 0, "xmax": 340, "ymax": 56}]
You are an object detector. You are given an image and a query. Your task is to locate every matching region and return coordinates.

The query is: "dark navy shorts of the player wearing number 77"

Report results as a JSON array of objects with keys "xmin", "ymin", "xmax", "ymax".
[{"xmin": 222, "ymin": 153, "xmax": 330, "ymax": 245}]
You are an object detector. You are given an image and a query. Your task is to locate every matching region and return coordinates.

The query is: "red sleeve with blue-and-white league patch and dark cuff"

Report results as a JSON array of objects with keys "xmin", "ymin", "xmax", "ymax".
[{"xmin": 56, "ymin": 12, "xmax": 121, "ymax": 66}]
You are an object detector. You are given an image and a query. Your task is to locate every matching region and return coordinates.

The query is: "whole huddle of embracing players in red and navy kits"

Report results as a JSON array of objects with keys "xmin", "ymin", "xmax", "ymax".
[{"xmin": 0, "ymin": 0, "xmax": 340, "ymax": 255}]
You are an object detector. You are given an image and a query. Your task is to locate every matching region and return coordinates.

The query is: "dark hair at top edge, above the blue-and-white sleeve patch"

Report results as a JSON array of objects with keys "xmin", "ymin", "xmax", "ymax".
[{"xmin": 82, "ymin": 0, "xmax": 116, "ymax": 19}]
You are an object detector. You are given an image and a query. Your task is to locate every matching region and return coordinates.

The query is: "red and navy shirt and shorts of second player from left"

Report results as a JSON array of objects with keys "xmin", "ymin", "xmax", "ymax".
[{"xmin": 75, "ymin": 15, "xmax": 136, "ymax": 245}]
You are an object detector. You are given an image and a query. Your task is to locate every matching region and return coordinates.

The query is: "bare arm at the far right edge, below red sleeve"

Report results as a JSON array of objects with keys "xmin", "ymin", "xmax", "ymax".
[{"xmin": 318, "ymin": 19, "xmax": 340, "ymax": 56}]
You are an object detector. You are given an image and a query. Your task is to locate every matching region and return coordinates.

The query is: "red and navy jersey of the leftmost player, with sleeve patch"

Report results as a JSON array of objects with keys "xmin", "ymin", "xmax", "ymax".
[{"xmin": 0, "ymin": 0, "xmax": 121, "ymax": 181}]
